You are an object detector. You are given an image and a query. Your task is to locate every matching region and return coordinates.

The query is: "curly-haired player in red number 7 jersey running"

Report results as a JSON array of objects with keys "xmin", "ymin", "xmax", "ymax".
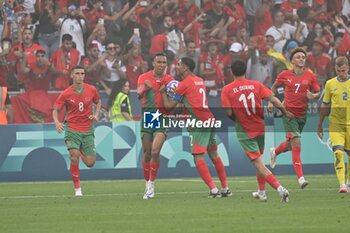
[{"xmin": 269, "ymin": 47, "xmax": 320, "ymax": 189}]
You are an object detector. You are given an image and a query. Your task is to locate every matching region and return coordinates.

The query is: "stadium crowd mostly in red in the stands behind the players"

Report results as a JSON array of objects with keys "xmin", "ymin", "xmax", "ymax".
[{"xmin": 0, "ymin": 0, "xmax": 350, "ymax": 122}]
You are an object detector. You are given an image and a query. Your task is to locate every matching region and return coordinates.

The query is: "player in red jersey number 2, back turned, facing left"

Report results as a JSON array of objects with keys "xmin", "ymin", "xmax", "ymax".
[{"xmin": 162, "ymin": 57, "xmax": 232, "ymax": 198}]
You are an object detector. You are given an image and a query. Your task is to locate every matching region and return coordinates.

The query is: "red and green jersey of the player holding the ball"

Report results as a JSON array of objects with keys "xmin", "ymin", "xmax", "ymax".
[{"xmin": 137, "ymin": 70, "xmax": 174, "ymax": 114}]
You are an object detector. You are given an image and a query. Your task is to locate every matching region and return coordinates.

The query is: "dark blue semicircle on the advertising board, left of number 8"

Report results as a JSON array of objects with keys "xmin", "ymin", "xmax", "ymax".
[{"xmin": 22, "ymin": 148, "xmax": 69, "ymax": 181}]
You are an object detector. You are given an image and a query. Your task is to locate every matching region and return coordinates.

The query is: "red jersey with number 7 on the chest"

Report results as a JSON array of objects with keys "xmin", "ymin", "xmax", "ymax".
[{"xmin": 276, "ymin": 69, "xmax": 320, "ymax": 117}]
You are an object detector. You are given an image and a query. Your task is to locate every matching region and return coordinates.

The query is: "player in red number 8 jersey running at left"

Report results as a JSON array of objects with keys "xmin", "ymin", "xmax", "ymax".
[{"xmin": 52, "ymin": 66, "xmax": 101, "ymax": 196}]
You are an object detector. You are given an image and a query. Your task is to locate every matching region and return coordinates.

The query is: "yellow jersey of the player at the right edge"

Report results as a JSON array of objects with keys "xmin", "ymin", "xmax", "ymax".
[{"xmin": 323, "ymin": 76, "xmax": 350, "ymax": 125}]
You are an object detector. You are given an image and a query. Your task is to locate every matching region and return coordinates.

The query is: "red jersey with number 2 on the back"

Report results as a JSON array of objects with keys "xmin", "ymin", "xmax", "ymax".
[{"xmin": 175, "ymin": 75, "xmax": 214, "ymax": 121}]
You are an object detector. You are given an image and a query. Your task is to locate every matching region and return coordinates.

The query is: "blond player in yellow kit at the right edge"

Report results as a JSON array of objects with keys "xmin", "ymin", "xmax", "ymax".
[{"xmin": 317, "ymin": 57, "xmax": 350, "ymax": 193}]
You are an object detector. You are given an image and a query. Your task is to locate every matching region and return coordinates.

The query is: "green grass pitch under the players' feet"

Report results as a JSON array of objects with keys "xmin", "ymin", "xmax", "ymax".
[{"xmin": 0, "ymin": 175, "xmax": 350, "ymax": 233}]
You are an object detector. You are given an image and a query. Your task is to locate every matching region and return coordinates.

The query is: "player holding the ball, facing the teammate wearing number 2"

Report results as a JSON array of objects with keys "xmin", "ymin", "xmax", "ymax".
[{"xmin": 137, "ymin": 53, "xmax": 174, "ymax": 199}]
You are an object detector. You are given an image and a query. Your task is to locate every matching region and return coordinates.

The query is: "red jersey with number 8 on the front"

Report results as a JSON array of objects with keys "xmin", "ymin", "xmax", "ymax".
[{"xmin": 54, "ymin": 83, "xmax": 100, "ymax": 133}]
